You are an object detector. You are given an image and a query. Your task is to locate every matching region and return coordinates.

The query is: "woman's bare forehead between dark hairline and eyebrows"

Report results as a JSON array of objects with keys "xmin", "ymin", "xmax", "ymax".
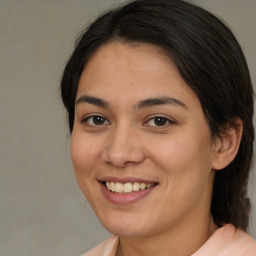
[{"xmin": 77, "ymin": 42, "xmax": 198, "ymax": 108}]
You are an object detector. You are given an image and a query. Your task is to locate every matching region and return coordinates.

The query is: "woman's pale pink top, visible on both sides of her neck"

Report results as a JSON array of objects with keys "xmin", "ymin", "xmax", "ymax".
[{"xmin": 82, "ymin": 224, "xmax": 256, "ymax": 256}]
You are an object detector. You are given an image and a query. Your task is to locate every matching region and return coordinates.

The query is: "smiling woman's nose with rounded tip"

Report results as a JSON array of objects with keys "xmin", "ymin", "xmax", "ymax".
[{"xmin": 102, "ymin": 126, "xmax": 146, "ymax": 168}]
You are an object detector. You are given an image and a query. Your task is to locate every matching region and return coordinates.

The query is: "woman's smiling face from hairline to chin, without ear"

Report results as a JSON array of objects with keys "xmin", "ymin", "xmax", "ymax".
[{"xmin": 71, "ymin": 42, "xmax": 219, "ymax": 237}]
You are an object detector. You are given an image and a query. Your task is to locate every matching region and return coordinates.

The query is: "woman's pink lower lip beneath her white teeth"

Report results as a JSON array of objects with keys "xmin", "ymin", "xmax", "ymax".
[{"xmin": 100, "ymin": 182, "xmax": 156, "ymax": 205}]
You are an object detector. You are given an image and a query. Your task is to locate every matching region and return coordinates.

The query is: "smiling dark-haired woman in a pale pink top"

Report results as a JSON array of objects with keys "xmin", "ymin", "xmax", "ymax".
[{"xmin": 61, "ymin": 0, "xmax": 256, "ymax": 256}]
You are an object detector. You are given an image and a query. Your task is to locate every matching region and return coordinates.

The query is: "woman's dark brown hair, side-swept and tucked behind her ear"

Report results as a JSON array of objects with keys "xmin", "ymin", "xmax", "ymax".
[{"xmin": 61, "ymin": 0, "xmax": 254, "ymax": 230}]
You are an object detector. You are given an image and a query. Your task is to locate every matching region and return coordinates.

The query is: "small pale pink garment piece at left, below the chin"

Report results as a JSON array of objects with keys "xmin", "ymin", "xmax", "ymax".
[{"xmin": 82, "ymin": 236, "xmax": 119, "ymax": 256}]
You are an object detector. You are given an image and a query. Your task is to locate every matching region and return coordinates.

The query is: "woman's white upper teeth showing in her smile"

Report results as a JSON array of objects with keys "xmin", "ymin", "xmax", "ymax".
[{"xmin": 106, "ymin": 181, "xmax": 154, "ymax": 193}]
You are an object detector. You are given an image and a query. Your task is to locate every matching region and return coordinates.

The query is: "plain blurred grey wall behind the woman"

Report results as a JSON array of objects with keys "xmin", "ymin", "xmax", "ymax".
[{"xmin": 0, "ymin": 0, "xmax": 256, "ymax": 256}]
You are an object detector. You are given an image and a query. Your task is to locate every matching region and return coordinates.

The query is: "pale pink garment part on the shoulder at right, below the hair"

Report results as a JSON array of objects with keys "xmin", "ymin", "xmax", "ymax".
[{"xmin": 193, "ymin": 224, "xmax": 256, "ymax": 256}]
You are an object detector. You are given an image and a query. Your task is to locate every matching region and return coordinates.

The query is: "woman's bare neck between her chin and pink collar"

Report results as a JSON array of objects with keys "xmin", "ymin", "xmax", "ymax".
[{"xmin": 116, "ymin": 216, "xmax": 217, "ymax": 256}]
